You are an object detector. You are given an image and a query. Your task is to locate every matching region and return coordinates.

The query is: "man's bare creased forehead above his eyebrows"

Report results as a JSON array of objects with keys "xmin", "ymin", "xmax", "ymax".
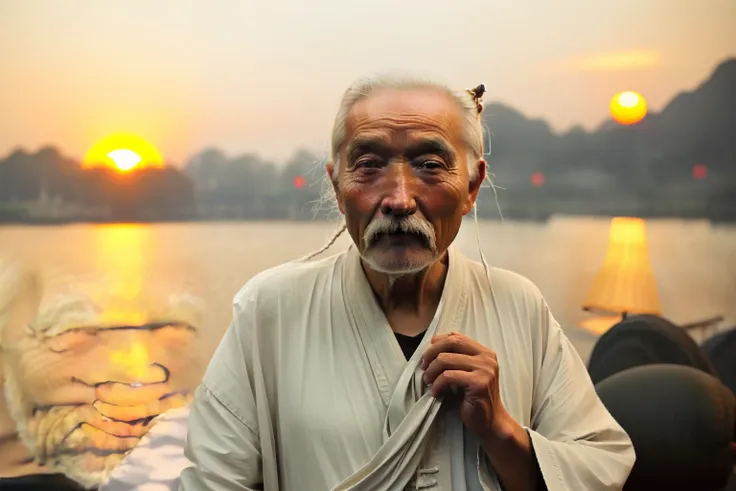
[{"xmin": 342, "ymin": 89, "xmax": 463, "ymax": 154}]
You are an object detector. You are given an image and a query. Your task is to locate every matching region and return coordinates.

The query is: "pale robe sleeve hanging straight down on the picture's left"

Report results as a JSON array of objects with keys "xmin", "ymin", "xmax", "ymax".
[{"xmin": 179, "ymin": 303, "xmax": 263, "ymax": 491}]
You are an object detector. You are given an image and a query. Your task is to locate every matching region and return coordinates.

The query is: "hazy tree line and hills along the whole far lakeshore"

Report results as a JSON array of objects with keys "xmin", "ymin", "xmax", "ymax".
[{"xmin": 0, "ymin": 59, "xmax": 736, "ymax": 221}]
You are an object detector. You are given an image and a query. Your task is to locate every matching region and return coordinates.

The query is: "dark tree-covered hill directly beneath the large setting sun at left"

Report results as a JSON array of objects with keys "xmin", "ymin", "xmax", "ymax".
[{"xmin": 0, "ymin": 147, "xmax": 196, "ymax": 222}]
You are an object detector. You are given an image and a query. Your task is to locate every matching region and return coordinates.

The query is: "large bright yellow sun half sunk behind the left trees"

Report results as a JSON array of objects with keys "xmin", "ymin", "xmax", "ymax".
[{"xmin": 83, "ymin": 133, "xmax": 164, "ymax": 172}]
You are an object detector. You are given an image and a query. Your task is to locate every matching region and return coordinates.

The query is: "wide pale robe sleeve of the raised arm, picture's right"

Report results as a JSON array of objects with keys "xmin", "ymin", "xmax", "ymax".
[{"xmin": 527, "ymin": 305, "xmax": 635, "ymax": 491}]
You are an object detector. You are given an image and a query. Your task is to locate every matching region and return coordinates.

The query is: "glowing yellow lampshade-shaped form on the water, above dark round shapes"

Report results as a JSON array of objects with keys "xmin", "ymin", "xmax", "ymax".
[{"xmin": 583, "ymin": 217, "xmax": 662, "ymax": 316}]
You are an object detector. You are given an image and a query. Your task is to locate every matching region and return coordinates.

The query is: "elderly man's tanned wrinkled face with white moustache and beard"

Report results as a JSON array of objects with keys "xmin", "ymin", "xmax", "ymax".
[{"xmin": 327, "ymin": 89, "xmax": 485, "ymax": 274}]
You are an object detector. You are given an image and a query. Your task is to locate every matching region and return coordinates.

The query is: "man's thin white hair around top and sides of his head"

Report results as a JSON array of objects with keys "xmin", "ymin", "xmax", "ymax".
[{"xmin": 330, "ymin": 75, "xmax": 483, "ymax": 181}]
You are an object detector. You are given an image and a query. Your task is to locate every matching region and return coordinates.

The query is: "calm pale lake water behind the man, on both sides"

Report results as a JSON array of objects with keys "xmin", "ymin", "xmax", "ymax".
[{"xmin": 0, "ymin": 217, "xmax": 736, "ymax": 370}]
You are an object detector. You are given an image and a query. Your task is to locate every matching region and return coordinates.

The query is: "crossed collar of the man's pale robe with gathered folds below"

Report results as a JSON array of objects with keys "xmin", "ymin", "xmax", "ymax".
[{"xmin": 333, "ymin": 246, "xmax": 469, "ymax": 491}]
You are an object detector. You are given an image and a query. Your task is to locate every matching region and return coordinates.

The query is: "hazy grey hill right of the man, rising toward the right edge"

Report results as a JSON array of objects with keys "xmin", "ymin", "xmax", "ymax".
[{"xmin": 484, "ymin": 59, "xmax": 736, "ymax": 220}]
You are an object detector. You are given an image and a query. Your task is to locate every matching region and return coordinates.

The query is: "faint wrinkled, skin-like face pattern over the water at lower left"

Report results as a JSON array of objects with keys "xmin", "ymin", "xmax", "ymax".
[{"xmin": 3, "ymin": 323, "xmax": 195, "ymax": 486}]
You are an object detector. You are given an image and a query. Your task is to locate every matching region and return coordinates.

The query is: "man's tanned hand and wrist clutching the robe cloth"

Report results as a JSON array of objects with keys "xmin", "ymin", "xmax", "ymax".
[{"xmin": 422, "ymin": 332, "xmax": 512, "ymax": 441}]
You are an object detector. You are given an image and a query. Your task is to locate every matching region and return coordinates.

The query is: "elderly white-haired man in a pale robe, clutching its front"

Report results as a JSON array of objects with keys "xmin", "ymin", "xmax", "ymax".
[{"xmin": 180, "ymin": 78, "xmax": 634, "ymax": 491}]
